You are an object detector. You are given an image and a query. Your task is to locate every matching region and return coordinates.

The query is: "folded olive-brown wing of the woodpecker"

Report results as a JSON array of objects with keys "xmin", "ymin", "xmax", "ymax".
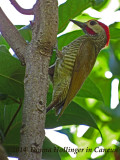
[{"xmin": 59, "ymin": 40, "xmax": 96, "ymax": 118}]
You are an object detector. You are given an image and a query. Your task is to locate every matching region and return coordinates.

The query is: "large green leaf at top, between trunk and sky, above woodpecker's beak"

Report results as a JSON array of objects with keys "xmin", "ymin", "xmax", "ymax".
[{"xmin": 58, "ymin": 0, "xmax": 91, "ymax": 33}]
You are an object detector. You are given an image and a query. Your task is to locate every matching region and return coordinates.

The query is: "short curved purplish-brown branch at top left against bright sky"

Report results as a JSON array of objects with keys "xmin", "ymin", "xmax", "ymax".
[{"xmin": 10, "ymin": 0, "xmax": 33, "ymax": 15}]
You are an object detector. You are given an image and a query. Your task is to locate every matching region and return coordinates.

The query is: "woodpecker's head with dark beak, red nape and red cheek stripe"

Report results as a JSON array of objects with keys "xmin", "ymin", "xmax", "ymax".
[{"xmin": 70, "ymin": 20, "xmax": 110, "ymax": 45}]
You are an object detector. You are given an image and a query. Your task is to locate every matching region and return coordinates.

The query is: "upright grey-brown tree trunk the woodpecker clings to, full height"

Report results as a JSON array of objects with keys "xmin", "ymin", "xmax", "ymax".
[{"xmin": 19, "ymin": 0, "xmax": 58, "ymax": 160}]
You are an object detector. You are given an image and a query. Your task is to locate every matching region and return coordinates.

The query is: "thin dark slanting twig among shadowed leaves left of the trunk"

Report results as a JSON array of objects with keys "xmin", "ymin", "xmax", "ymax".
[{"xmin": 4, "ymin": 100, "xmax": 22, "ymax": 137}]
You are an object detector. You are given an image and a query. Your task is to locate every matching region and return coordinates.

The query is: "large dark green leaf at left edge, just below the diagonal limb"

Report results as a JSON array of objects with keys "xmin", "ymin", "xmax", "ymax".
[{"xmin": 0, "ymin": 46, "xmax": 25, "ymax": 98}]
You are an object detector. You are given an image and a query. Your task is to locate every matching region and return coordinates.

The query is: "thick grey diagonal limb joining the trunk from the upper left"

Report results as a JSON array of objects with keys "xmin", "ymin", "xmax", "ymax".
[{"xmin": 0, "ymin": 7, "xmax": 27, "ymax": 64}]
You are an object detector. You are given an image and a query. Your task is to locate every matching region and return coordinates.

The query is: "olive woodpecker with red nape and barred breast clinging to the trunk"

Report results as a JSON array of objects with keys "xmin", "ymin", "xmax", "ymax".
[{"xmin": 47, "ymin": 20, "xmax": 110, "ymax": 116}]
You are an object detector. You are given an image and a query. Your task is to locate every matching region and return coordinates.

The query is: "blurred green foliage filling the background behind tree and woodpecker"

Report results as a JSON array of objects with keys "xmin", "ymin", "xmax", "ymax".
[{"xmin": 0, "ymin": 0, "xmax": 120, "ymax": 160}]
